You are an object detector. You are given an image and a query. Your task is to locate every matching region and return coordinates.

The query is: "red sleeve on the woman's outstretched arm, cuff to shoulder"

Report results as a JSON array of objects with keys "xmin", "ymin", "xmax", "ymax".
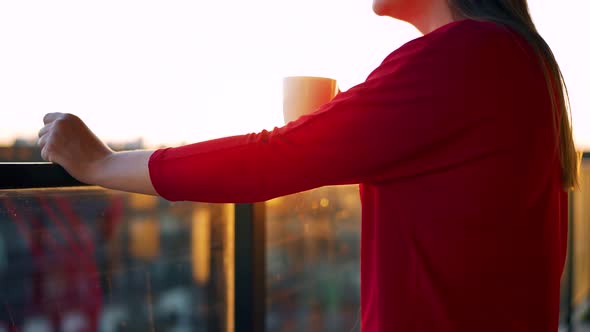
[{"xmin": 149, "ymin": 22, "xmax": 532, "ymax": 202}]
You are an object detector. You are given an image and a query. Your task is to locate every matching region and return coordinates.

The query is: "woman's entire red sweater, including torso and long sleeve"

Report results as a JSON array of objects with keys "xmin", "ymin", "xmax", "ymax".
[{"xmin": 149, "ymin": 20, "xmax": 567, "ymax": 332}]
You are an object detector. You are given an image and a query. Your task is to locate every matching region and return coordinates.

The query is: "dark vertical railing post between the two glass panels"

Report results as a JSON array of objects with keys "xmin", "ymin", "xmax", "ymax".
[{"xmin": 234, "ymin": 203, "xmax": 266, "ymax": 332}]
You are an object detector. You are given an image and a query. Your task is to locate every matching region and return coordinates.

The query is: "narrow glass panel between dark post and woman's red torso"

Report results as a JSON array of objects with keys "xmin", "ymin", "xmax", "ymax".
[{"xmin": 266, "ymin": 186, "xmax": 361, "ymax": 331}]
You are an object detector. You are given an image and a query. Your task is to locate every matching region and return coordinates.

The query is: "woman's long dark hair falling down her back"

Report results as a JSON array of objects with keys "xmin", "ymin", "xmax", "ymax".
[{"xmin": 448, "ymin": 0, "xmax": 579, "ymax": 190}]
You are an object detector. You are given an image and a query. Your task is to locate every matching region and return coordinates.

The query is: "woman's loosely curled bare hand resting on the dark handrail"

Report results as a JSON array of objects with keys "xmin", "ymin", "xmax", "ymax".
[{"xmin": 38, "ymin": 113, "xmax": 114, "ymax": 184}]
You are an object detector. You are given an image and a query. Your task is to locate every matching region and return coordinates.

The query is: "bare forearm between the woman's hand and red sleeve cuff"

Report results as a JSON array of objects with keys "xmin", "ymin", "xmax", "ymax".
[{"xmin": 88, "ymin": 150, "xmax": 157, "ymax": 195}]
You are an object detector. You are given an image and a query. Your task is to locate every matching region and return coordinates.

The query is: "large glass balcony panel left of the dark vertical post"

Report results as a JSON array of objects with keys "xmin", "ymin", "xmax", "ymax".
[{"xmin": 0, "ymin": 188, "xmax": 234, "ymax": 332}]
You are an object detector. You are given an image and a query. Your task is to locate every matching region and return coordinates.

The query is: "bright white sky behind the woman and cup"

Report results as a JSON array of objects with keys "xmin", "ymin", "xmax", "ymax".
[{"xmin": 0, "ymin": 0, "xmax": 590, "ymax": 148}]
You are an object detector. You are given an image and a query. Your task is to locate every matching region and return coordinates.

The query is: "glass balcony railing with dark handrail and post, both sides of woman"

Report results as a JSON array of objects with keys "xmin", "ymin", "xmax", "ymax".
[{"xmin": 0, "ymin": 155, "xmax": 590, "ymax": 332}]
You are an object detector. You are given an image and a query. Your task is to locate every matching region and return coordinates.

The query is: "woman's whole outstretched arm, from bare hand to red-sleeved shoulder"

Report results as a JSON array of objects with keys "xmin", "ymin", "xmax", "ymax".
[{"xmin": 40, "ymin": 22, "xmax": 531, "ymax": 202}]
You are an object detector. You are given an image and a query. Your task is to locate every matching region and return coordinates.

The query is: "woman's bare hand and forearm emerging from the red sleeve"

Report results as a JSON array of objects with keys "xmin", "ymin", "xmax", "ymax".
[{"xmin": 39, "ymin": 113, "xmax": 157, "ymax": 195}]
